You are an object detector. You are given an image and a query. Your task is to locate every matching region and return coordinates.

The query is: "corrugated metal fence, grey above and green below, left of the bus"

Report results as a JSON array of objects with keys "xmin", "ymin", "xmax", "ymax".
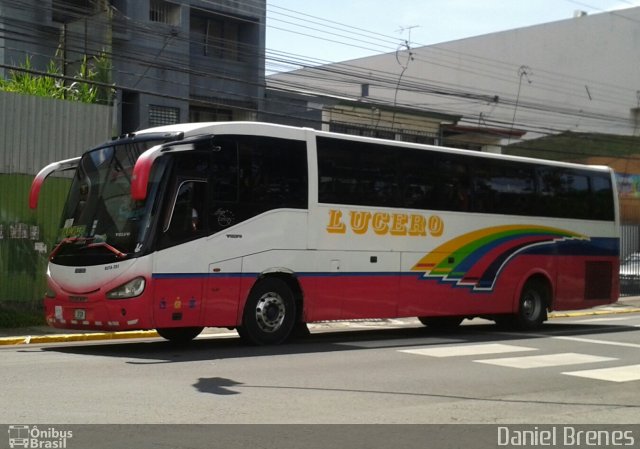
[{"xmin": 0, "ymin": 92, "xmax": 113, "ymax": 327}]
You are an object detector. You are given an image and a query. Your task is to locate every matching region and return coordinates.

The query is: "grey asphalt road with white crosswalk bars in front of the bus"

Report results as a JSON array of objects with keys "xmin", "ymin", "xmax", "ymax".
[{"xmin": 0, "ymin": 313, "xmax": 640, "ymax": 424}]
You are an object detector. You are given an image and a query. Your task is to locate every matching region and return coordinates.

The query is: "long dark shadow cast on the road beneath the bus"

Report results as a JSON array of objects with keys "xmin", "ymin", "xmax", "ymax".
[{"xmin": 40, "ymin": 323, "xmax": 638, "ymax": 364}]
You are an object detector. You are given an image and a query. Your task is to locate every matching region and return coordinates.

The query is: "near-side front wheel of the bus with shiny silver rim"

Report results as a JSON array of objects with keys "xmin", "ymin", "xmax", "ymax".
[{"xmin": 238, "ymin": 277, "xmax": 296, "ymax": 345}]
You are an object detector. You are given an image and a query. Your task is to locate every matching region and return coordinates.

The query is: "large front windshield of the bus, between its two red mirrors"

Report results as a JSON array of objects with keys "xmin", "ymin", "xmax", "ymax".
[{"xmin": 52, "ymin": 140, "xmax": 168, "ymax": 264}]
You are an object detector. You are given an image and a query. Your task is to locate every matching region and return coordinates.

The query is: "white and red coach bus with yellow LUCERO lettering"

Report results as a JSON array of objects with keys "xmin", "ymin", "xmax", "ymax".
[{"xmin": 30, "ymin": 122, "xmax": 619, "ymax": 344}]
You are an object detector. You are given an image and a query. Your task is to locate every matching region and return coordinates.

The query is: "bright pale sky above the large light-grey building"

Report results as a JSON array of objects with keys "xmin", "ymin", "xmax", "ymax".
[{"xmin": 266, "ymin": 0, "xmax": 640, "ymax": 73}]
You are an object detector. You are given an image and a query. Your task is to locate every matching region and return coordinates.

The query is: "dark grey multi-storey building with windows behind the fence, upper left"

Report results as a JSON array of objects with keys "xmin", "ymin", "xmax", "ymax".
[{"xmin": 0, "ymin": 0, "xmax": 266, "ymax": 132}]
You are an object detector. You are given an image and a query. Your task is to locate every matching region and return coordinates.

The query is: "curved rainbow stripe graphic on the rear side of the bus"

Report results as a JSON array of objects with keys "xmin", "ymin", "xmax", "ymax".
[{"xmin": 411, "ymin": 225, "xmax": 589, "ymax": 291}]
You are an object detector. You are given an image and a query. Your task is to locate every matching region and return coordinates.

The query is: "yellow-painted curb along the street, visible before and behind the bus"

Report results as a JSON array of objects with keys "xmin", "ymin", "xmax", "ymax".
[{"xmin": 0, "ymin": 307, "xmax": 640, "ymax": 346}]
